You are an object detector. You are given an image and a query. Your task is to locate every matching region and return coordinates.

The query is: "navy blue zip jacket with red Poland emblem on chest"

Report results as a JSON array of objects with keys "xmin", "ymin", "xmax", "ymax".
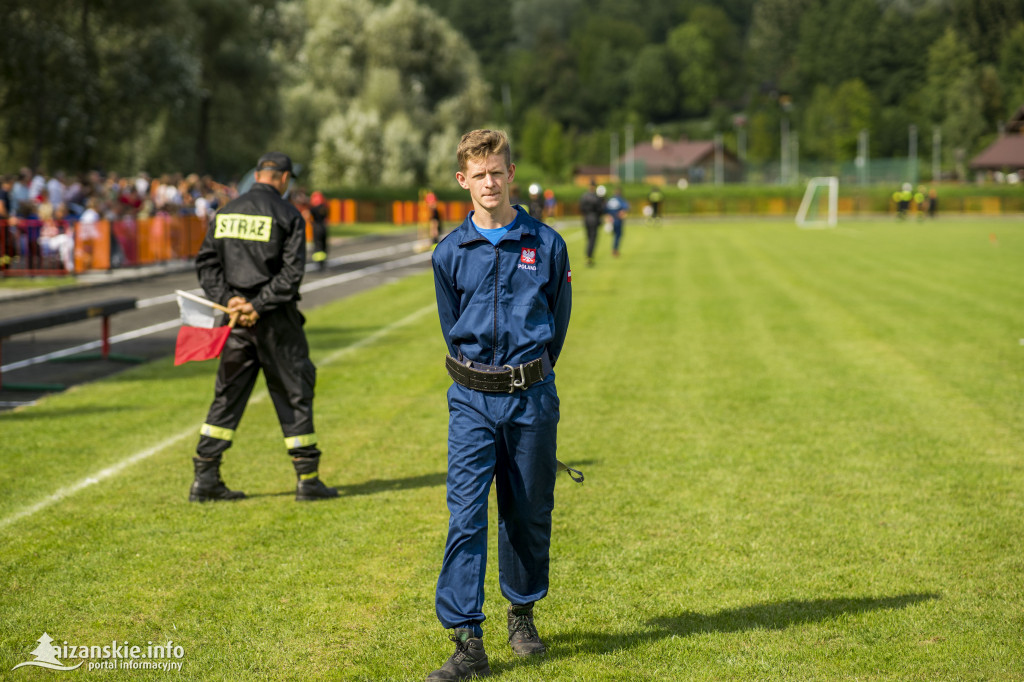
[{"xmin": 432, "ymin": 209, "xmax": 572, "ymax": 367}]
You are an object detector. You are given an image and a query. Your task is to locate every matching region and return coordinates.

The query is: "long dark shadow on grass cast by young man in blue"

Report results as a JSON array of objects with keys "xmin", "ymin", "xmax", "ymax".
[{"xmin": 546, "ymin": 592, "xmax": 941, "ymax": 657}]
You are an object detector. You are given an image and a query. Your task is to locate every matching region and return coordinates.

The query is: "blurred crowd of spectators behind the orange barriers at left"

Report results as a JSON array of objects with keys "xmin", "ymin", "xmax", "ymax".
[{"xmin": 0, "ymin": 168, "xmax": 238, "ymax": 270}]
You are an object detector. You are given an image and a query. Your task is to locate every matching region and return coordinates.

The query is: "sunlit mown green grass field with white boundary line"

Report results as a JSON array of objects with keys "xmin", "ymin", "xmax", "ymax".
[{"xmin": 0, "ymin": 217, "xmax": 1024, "ymax": 681}]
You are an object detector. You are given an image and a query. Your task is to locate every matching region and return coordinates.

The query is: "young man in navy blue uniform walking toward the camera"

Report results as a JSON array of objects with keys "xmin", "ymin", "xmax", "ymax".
[{"xmin": 427, "ymin": 130, "xmax": 572, "ymax": 680}]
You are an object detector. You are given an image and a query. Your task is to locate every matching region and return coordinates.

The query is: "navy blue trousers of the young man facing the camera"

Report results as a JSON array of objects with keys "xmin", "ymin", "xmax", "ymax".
[{"xmin": 435, "ymin": 376, "xmax": 558, "ymax": 636}]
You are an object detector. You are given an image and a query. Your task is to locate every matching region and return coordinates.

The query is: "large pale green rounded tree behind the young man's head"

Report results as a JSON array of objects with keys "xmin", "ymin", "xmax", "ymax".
[{"xmin": 282, "ymin": 0, "xmax": 489, "ymax": 186}]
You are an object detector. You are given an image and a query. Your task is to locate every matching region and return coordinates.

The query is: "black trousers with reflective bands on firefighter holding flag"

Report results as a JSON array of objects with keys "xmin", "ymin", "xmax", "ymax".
[{"xmin": 196, "ymin": 303, "xmax": 321, "ymax": 459}]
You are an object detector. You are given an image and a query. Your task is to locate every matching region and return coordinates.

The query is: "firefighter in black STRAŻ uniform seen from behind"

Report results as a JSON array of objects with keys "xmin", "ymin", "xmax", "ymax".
[{"xmin": 188, "ymin": 152, "xmax": 338, "ymax": 502}]
